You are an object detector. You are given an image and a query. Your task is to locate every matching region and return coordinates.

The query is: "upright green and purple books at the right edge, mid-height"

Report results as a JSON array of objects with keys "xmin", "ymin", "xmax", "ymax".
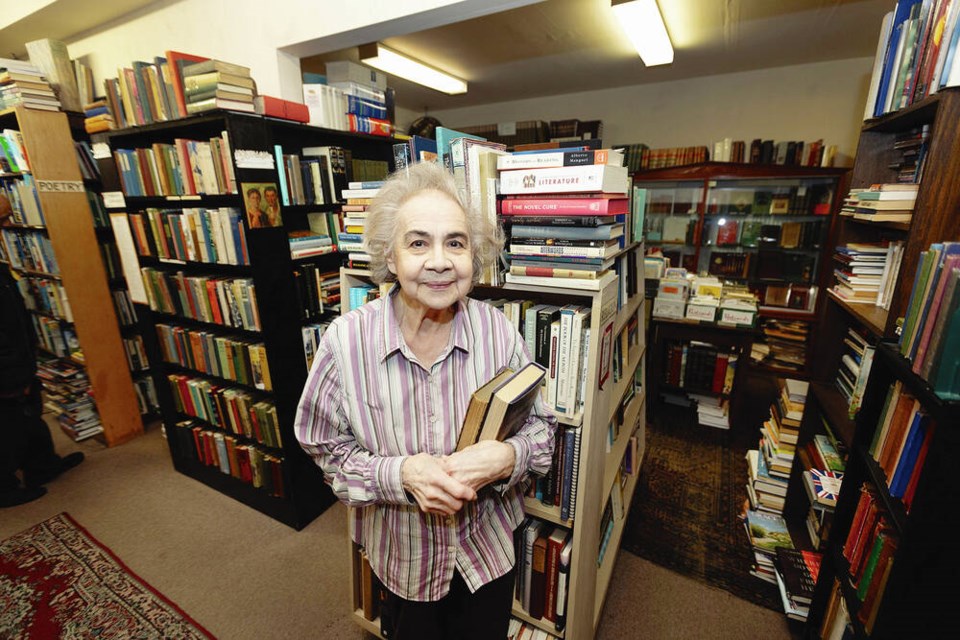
[{"xmin": 900, "ymin": 242, "xmax": 960, "ymax": 400}]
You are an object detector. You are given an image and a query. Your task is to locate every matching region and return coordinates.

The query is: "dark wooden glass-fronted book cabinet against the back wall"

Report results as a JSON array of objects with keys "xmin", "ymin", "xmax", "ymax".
[{"xmin": 633, "ymin": 162, "xmax": 847, "ymax": 377}]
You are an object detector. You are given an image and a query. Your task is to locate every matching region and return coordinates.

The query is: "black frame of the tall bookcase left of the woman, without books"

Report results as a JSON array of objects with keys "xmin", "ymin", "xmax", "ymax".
[{"xmin": 94, "ymin": 111, "xmax": 391, "ymax": 529}]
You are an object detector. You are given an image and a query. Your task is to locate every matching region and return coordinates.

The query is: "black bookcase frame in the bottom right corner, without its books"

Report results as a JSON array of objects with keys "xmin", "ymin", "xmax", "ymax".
[{"xmin": 806, "ymin": 342, "xmax": 960, "ymax": 638}]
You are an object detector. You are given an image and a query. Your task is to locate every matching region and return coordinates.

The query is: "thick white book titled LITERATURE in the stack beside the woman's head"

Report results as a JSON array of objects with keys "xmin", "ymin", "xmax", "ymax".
[{"xmin": 500, "ymin": 164, "xmax": 630, "ymax": 195}]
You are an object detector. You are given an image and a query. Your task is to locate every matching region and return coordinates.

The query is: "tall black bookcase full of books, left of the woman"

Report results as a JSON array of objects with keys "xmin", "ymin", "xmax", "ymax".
[{"xmin": 94, "ymin": 111, "xmax": 391, "ymax": 530}]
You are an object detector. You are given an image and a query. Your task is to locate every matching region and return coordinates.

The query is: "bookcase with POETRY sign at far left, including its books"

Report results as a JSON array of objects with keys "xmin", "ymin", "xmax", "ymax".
[{"xmin": 0, "ymin": 106, "xmax": 142, "ymax": 446}]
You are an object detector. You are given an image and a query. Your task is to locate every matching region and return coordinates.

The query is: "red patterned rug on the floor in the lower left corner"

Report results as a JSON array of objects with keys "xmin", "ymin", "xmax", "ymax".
[{"xmin": 0, "ymin": 513, "xmax": 213, "ymax": 639}]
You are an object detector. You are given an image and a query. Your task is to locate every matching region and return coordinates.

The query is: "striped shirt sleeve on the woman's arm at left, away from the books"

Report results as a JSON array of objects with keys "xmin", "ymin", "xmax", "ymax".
[{"xmin": 294, "ymin": 326, "xmax": 411, "ymax": 507}]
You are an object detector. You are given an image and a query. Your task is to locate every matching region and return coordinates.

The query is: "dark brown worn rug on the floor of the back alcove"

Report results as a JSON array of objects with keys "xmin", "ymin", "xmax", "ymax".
[{"xmin": 621, "ymin": 376, "xmax": 783, "ymax": 612}]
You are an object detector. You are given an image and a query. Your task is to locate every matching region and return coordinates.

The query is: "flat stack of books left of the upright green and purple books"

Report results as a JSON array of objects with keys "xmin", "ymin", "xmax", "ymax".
[{"xmin": 830, "ymin": 241, "xmax": 903, "ymax": 309}]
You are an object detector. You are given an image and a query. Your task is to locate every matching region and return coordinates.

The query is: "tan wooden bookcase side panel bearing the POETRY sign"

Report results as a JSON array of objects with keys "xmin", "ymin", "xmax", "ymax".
[{"xmin": 0, "ymin": 107, "xmax": 143, "ymax": 446}]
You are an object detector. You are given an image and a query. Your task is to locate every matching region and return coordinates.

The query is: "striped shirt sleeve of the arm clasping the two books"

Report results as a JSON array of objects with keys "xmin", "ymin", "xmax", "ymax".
[{"xmin": 491, "ymin": 322, "xmax": 557, "ymax": 493}]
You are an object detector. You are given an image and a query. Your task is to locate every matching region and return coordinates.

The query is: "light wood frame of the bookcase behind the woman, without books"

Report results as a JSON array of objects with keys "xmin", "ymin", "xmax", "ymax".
[{"xmin": 341, "ymin": 242, "xmax": 646, "ymax": 639}]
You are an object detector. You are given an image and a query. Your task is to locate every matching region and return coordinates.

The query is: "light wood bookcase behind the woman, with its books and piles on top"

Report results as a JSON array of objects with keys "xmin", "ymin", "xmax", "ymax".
[{"xmin": 341, "ymin": 136, "xmax": 646, "ymax": 638}]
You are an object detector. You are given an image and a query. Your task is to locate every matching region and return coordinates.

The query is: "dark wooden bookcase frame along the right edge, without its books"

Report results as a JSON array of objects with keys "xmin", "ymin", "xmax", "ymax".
[{"xmin": 800, "ymin": 88, "xmax": 960, "ymax": 637}]
